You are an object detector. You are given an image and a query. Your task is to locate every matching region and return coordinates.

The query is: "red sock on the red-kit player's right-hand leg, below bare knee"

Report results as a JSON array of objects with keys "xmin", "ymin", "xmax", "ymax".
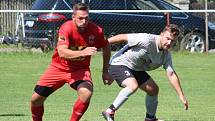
[{"xmin": 70, "ymin": 98, "xmax": 89, "ymax": 121}]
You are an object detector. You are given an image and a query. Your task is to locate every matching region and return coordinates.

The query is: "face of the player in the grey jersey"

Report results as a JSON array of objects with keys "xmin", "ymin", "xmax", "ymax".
[{"xmin": 160, "ymin": 31, "xmax": 176, "ymax": 50}]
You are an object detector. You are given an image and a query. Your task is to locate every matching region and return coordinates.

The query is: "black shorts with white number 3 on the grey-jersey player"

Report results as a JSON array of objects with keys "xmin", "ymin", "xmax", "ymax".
[{"xmin": 109, "ymin": 65, "xmax": 151, "ymax": 86}]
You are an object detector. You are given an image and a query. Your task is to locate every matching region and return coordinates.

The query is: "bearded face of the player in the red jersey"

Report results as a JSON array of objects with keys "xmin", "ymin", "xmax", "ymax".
[{"xmin": 73, "ymin": 10, "xmax": 89, "ymax": 32}]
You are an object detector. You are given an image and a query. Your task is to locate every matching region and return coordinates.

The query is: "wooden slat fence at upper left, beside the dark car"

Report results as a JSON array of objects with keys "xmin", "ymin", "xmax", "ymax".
[{"xmin": 0, "ymin": 0, "xmax": 34, "ymax": 35}]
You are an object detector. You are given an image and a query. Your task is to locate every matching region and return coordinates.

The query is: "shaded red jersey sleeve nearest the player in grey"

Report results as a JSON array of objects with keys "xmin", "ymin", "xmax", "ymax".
[{"xmin": 96, "ymin": 27, "xmax": 108, "ymax": 48}]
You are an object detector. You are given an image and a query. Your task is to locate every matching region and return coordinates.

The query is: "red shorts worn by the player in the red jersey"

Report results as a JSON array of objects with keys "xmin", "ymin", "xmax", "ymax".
[{"xmin": 37, "ymin": 65, "xmax": 92, "ymax": 90}]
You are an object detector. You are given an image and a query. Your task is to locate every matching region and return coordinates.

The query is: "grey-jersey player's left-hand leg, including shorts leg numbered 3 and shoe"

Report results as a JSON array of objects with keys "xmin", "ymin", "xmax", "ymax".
[{"xmin": 102, "ymin": 65, "xmax": 138, "ymax": 121}]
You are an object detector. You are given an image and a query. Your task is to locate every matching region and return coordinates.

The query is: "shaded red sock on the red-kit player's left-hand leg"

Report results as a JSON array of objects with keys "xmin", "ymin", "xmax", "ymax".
[{"xmin": 31, "ymin": 105, "xmax": 44, "ymax": 121}]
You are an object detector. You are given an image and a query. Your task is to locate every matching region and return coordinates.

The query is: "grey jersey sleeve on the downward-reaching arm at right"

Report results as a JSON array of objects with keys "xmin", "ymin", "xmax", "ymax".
[{"xmin": 163, "ymin": 52, "xmax": 174, "ymax": 73}]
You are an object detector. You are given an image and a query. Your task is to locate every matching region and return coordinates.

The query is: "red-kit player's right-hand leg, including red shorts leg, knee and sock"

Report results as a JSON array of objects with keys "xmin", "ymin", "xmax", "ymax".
[{"xmin": 67, "ymin": 68, "xmax": 93, "ymax": 121}]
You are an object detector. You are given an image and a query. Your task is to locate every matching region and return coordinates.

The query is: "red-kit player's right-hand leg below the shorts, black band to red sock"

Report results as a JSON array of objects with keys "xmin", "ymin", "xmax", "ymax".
[{"xmin": 70, "ymin": 80, "xmax": 93, "ymax": 121}]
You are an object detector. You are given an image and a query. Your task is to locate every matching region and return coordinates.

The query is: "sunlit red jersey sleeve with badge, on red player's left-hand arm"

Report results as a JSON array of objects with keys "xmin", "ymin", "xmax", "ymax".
[{"xmin": 57, "ymin": 24, "xmax": 72, "ymax": 46}]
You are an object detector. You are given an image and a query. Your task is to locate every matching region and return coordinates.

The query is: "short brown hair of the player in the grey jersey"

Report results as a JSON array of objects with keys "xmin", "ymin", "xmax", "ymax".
[{"xmin": 162, "ymin": 24, "xmax": 180, "ymax": 37}]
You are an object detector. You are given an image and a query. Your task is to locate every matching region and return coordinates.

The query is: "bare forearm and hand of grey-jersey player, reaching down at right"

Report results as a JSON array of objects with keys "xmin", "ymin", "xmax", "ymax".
[{"xmin": 167, "ymin": 71, "xmax": 188, "ymax": 110}]
